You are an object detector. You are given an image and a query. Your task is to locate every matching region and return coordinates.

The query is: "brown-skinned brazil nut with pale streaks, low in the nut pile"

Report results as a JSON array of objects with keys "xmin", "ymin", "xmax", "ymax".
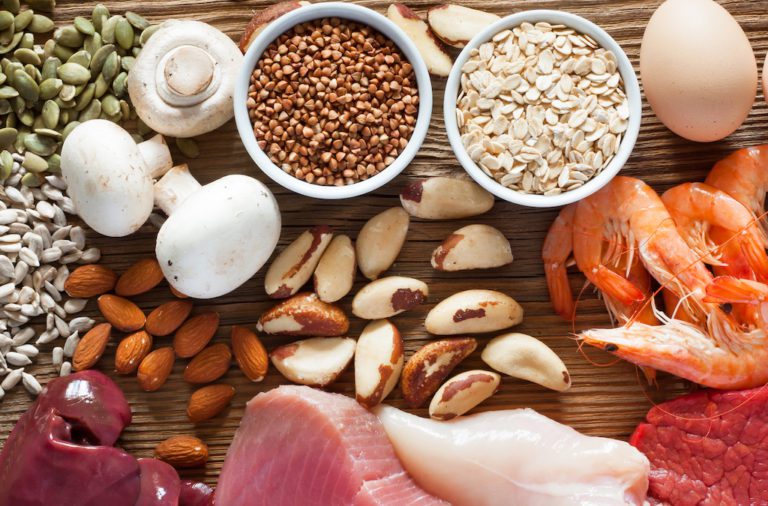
[{"xmin": 400, "ymin": 337, "xmax": 477, "ymax": 408}]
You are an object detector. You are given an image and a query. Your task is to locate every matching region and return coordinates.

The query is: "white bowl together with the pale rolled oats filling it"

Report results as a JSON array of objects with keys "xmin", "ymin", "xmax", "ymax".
[{"xmin": 444, "ymin": 10, "xmax": 642, "ymax": 207}]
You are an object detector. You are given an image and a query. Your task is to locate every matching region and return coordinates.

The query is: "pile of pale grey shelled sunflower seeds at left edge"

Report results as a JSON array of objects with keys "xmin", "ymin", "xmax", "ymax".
[{"xmin": 0, "ymin": 151, "xmax": 101, "ymax": 399}]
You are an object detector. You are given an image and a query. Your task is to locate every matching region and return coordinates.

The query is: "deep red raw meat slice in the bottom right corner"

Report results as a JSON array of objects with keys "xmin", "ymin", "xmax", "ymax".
[{"xmin": 630, "ymin": 387, "xmax": 768, "ymax": 506}]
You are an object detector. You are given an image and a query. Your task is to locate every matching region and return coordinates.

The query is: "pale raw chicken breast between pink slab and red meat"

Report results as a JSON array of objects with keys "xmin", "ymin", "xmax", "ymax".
[{"xmin": 374, "ymin": 406, "xmax": 649, "ymax": 506}]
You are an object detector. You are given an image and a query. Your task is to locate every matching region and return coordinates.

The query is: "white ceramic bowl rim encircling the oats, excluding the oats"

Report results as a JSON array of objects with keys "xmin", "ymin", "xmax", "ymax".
[{"xmin": 443, "ymin": 10, "xmax": 642, "ymax": 207}]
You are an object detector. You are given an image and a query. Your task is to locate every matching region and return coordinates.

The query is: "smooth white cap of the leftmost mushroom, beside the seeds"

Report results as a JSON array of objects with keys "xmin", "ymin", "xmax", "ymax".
[{"xmin": 61, "ymin": 119, "xmax": 154, "ymax": 237}]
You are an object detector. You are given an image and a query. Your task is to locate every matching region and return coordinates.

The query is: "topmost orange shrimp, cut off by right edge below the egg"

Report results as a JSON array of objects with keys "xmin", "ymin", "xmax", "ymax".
[{"xmin": 704, "ymin": 144, "xmax": 768, "ymax": 246}]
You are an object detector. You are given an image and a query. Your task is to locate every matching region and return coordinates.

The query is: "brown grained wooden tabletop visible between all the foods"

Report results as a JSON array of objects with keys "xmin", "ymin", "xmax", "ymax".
[{"xmin": 0, "ymin": 0, "xmax": 768, "ymax": 483}]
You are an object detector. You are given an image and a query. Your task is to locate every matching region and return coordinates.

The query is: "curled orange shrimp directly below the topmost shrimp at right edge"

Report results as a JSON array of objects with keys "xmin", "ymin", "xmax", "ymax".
[{"xmin": 661, "ymin": 183, "xmax": 768, "ymax": 279}]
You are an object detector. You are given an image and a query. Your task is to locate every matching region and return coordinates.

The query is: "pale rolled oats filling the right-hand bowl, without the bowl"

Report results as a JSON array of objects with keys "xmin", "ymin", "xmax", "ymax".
[{"xmin": 456, "ymin": 23, "xmax": 629, "ymax": 195}]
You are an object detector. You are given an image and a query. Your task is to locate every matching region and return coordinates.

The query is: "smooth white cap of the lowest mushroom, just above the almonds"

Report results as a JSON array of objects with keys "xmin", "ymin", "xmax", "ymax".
[{"xmin": 155, "ymin": 175, "xmax": 281, "ymax": 299}]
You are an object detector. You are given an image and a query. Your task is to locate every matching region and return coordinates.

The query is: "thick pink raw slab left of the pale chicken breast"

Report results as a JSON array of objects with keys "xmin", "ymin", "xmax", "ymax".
[{"xmin": 214, "ymin": 386, "xmax": 446, "ymax": 506}]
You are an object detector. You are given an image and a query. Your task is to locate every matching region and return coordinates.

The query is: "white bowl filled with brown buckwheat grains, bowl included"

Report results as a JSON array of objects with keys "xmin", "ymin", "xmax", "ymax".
[{"xmin": 234, "ymin": 2, "xmax": 432, "ymax": 199}]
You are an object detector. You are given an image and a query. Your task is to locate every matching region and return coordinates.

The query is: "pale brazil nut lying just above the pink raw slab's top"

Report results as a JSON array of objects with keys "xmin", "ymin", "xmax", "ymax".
[{"xmin": 270, "ymin": 337, "xmax": 355, "ymax": 387}]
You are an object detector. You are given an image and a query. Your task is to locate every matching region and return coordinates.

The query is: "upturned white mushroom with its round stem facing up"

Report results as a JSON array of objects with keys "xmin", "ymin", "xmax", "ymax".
[{"xmin": 128, "ymin": 20, "xmax": 243, "ymax": 138}]
